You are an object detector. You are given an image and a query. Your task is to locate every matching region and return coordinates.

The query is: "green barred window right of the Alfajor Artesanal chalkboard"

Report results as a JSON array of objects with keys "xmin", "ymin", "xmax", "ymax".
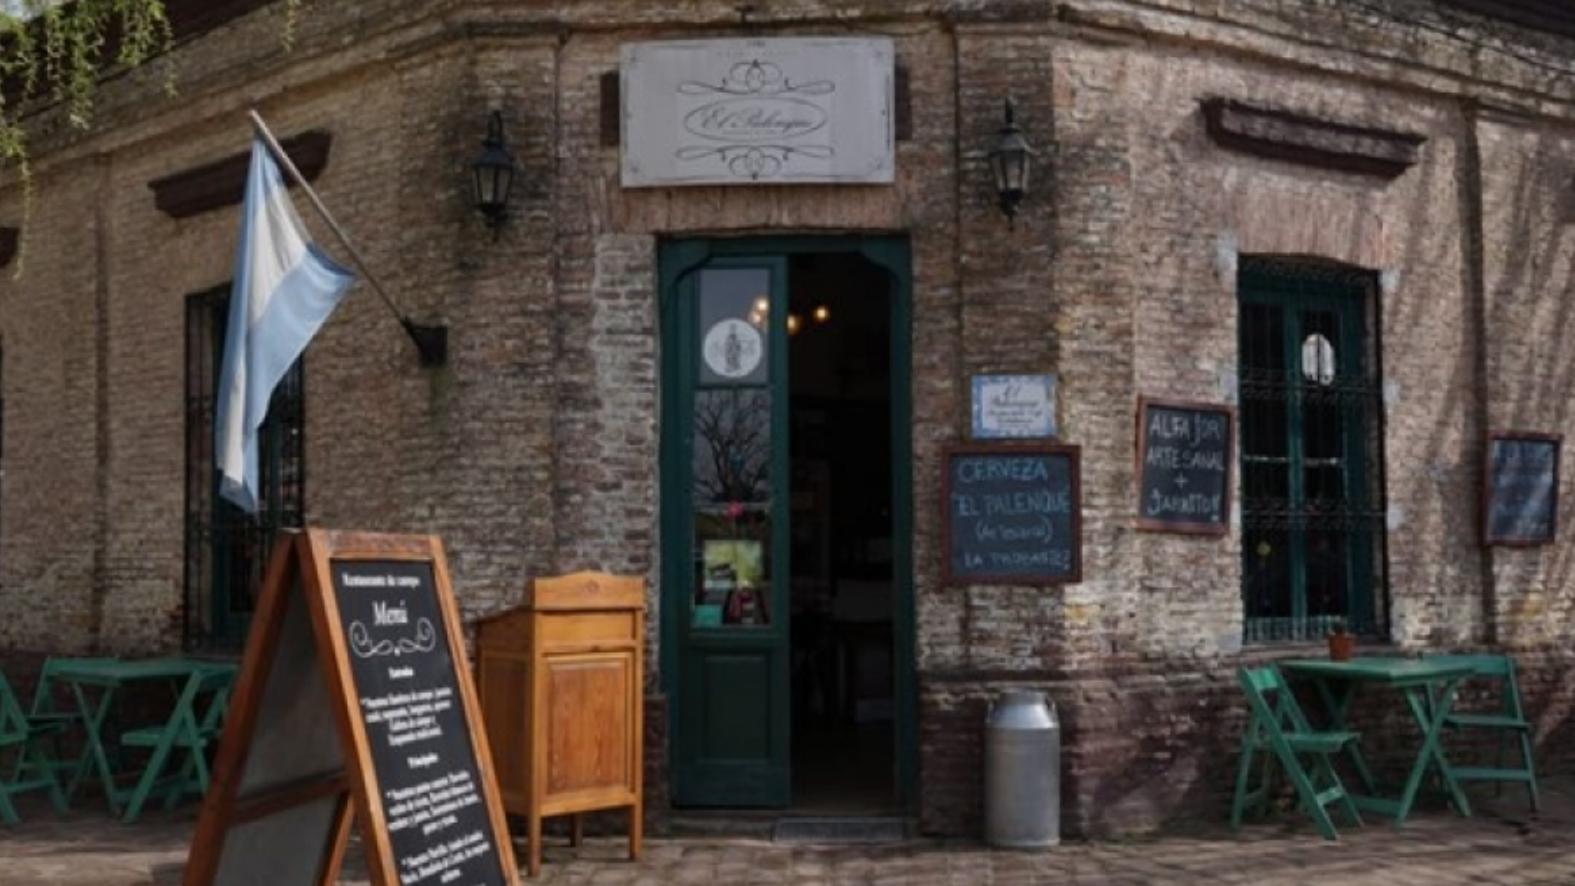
[{"xmin": 1238, "ymin": 257, "xmax": 1384, "ymax": 642}]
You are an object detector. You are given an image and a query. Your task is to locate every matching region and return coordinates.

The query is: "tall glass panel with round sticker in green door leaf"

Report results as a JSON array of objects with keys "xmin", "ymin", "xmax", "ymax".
[{"xmin": 690, "ymin": 268, "xmax": 773, "ymax": 628}]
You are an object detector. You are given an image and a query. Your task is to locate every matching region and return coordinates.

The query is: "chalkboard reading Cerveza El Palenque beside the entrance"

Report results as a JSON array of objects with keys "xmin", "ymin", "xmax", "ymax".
[{"xmin": 942, "ymin": 444, "xmax": 1082, "ymax": 584}]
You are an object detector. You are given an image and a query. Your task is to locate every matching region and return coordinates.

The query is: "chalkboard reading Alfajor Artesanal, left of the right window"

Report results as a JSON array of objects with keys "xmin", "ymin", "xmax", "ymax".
[{"xmin": 1137, "ymin": 398, "xmax": 1235, "ymax": 535}]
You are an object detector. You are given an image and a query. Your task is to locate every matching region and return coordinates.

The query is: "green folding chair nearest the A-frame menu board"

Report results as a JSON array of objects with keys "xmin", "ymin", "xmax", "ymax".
[{"xmin": 120, "ymin": 666, "xmax": 235, "ymax": 823}]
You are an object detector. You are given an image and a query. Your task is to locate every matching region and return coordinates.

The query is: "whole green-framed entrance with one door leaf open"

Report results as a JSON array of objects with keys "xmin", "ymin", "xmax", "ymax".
[{"xmin": 660, "ymin": 236, "xmax": 918, "ymax": 817}]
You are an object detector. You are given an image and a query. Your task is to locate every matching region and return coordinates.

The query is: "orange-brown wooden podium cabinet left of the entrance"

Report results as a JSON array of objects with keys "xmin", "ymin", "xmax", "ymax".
[{"xmin": 476, "ymin": 573, "xmax": 646, "ymax": 877}]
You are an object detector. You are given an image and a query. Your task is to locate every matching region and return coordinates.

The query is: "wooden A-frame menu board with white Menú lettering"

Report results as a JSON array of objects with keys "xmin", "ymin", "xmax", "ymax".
[{"xmin": 184, "ymin": 529, "xmax": 518, "ymax": 886}]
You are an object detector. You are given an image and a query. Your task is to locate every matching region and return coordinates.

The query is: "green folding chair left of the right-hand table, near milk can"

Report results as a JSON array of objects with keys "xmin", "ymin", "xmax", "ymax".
[{"xmin": 1230, "ymin": 664, "xmax": 1362, "ymax": 840}]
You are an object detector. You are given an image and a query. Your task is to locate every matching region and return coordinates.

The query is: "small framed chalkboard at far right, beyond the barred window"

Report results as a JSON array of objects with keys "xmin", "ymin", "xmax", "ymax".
[{"xmin": 1482, "ymin": 431, "xmax": 1562, "ymax": 545}]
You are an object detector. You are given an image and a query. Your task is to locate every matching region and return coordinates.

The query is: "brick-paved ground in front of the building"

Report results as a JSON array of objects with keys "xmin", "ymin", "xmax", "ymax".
[{"xmin": 0, "ymin": 779, "xmax": 1575, "ymax": 886}]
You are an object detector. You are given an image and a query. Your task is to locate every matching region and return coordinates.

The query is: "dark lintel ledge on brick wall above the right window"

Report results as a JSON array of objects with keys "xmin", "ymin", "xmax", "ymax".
[{"xmin": 1203, "ymin": 98, "xmax": 1427, "ymax": 178}]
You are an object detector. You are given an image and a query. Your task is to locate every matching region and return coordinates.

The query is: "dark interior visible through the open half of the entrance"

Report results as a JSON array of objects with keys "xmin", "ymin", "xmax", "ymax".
[{"xmin": 788, "ymin": 253, "xmax": 896, "ymax": 814}]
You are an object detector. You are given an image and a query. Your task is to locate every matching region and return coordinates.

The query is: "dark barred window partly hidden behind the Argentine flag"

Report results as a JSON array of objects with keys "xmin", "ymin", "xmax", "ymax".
[{"xmin": 183, "ymin": 285, "xmax": 306, "ymax": 650}]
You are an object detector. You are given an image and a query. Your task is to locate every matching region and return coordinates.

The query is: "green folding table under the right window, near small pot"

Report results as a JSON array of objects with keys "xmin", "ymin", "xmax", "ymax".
[{"xmin": 1277, "ymin": 656, "xmax": 1476, "ymax": 825}]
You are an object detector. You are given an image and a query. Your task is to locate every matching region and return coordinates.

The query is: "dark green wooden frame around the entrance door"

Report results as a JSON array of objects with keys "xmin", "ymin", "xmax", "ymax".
[{"xmin": 657, "ymin": 234, "xmax": 918, "ymax": 814}]
